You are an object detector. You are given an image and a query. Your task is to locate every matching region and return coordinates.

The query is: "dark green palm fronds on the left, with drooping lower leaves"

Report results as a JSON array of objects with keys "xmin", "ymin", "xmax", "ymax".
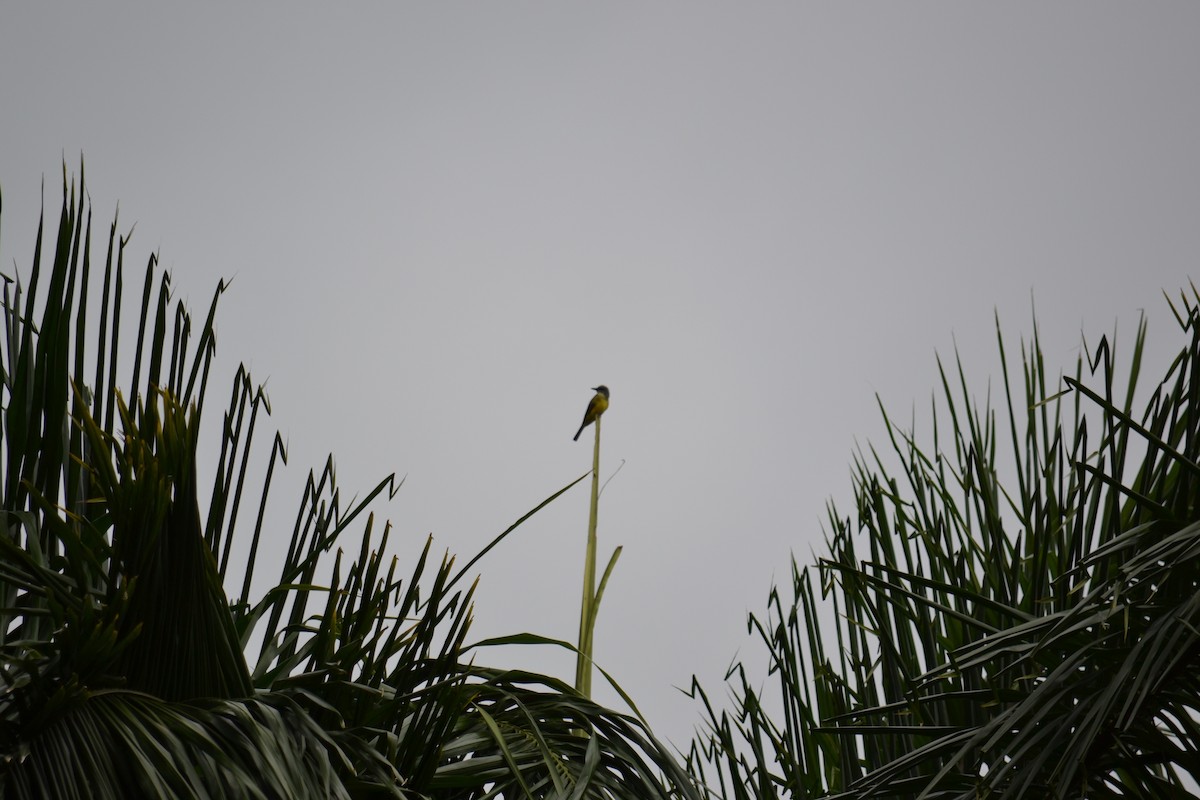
[{"xmin": 0, "ymin": 170, "xmax": 700, "ymax": 799}]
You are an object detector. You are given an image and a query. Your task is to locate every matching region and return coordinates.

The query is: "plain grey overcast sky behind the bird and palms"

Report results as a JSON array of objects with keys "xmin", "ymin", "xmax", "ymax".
[{"xmin": 0, "ymin": 0, "xmax": 1200, "ymax": 746}]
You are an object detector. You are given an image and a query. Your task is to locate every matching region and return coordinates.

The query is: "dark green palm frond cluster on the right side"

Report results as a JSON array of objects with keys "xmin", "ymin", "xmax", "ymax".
[{"xmin": 690, "ymin": 297, "xmax": 1200, "ymax": 800}]
